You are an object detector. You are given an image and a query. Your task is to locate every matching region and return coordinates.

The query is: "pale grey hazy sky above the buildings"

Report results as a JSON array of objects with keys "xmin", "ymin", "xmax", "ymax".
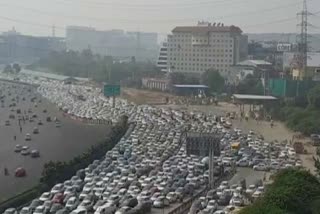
[{"xmin": 0, "ymin": 0, "xmax": 320, "ymax": 36}]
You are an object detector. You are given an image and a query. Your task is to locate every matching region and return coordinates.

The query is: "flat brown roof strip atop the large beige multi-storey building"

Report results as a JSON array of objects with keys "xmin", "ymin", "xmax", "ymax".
[{"xmin": 172, "ymin": 25, "xmax": 242, "ymax": 33}]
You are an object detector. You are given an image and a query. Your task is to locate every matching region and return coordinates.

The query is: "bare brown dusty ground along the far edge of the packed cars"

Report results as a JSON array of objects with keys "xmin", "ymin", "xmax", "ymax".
[{"xmin": 123, "ymin": 89, "xmax": 316, "ymax": 173}]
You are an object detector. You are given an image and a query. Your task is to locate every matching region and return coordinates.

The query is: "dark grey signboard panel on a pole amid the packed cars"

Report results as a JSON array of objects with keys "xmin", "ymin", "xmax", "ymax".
[{"xmin": 186, "ymin": 133, "xmax": 221, "ymax": 157}]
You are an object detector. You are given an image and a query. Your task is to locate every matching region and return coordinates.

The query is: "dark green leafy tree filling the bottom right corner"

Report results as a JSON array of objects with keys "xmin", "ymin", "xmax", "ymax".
[{"xmin": 241, "ymin": 169, "xmax": 320, "ymax": 214}]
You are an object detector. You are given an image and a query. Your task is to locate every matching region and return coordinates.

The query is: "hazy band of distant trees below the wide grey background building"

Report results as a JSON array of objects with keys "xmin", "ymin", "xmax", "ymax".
[{"xmin": 26, "ymin": 49, "xmax": 161, "ymax": 82}]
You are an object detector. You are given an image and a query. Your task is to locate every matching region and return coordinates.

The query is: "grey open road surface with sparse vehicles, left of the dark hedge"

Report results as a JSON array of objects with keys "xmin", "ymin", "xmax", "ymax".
[{"xmin": 0, "ymin": 82, "xmax": 109, "ymax": 201}]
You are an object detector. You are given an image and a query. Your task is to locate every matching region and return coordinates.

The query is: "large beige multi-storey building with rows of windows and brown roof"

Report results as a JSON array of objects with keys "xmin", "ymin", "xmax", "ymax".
[{"xmin": 168, "ymin": 22, "xmax": 247, "ymax": 77}]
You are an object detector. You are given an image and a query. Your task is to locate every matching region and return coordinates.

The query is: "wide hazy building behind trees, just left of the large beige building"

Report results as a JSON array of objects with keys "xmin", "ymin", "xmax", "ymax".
[{"xmin": 66, "ymin": 26, "xmax": 158, "ymax": 61}]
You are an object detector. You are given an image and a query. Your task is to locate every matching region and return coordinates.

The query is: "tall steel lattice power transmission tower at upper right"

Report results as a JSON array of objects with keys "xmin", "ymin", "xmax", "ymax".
[{"xmin": 296, "ymin": 0, "xmax": 312, "ymax": 73}]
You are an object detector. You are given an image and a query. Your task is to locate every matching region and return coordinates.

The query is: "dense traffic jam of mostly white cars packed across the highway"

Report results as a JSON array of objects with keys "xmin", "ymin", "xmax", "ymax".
[{"xmin": 4, "ymin": 75, "xmax": 302, "ymax": 214}]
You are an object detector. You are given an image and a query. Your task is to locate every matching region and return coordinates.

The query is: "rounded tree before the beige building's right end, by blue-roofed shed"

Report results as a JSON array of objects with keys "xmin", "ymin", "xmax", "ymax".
[{"xmin": 201, "ymin": 69, "xmax": 225, "ymax": 93}]
